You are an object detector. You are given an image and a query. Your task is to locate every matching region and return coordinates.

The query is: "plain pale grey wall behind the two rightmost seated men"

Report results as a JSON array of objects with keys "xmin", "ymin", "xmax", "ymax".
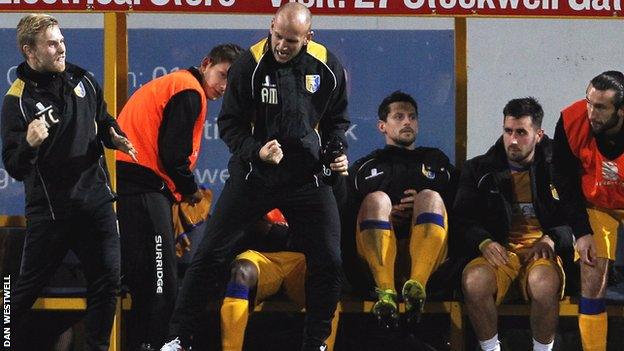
[{"xmin": 467, "ymin": 19, "xmax": 624, "ymax": 157}]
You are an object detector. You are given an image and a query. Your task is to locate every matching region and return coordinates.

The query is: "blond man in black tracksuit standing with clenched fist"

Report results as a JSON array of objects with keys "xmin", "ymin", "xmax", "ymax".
[{"xmin": 1, "ymin": 14, "xmax": 134, "ymax": 350}]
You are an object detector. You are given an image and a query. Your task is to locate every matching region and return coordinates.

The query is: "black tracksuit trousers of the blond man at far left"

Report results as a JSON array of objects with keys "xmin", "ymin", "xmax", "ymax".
[{"xmin": 11, "ymin": 202, "xmax": 119, "ymax": 351}]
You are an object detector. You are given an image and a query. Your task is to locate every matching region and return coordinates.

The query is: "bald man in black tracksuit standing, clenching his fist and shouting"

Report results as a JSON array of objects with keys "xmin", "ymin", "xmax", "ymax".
[{"xmin": 161, "ymin": 3, "xmax": 349, "ymax": 351}]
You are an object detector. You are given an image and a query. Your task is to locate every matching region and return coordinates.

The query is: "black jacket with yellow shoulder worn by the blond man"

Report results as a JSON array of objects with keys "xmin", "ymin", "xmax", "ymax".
[{"xmin": 0, "ymin": 62, "xmax": 123, "ymax": 219}]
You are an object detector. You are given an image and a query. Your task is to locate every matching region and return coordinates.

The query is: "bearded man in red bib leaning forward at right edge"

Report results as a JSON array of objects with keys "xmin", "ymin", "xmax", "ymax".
[{"xmin": 554, "ymin": 71, "xmax": 624, "ymax": 351}]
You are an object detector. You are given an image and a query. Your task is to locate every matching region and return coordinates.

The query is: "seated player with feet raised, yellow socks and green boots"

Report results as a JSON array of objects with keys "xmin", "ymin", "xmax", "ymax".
[{"xmin": 347, "ymin": 91, "xmax": 454, "ymax": 327}]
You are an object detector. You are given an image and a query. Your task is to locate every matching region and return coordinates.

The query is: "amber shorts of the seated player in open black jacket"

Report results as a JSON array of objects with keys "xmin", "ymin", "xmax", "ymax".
[{"xmin": 464, "ymin": 251, "xmax": 565, "ymax": 305}]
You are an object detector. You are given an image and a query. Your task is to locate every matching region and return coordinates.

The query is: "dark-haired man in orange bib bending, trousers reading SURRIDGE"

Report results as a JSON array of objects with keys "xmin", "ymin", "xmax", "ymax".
[{"xmin": 117, "ymin": 44, "xmax": 242, "ymax": 351}]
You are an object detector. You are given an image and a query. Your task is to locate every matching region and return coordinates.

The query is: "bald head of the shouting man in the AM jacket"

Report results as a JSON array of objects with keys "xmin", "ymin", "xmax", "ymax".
[{"xmin": 270, "ymin": 2, "xmax": 313, "ymax": 63}]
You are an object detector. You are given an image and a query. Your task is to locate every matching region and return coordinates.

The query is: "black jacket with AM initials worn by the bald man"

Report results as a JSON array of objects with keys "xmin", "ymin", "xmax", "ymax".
[{"xmin": 218, "ymin": 39, "xmax": 349, "ymax": 187}]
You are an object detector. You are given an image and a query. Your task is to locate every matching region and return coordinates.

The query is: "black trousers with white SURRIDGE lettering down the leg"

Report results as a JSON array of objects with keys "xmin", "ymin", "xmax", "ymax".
[{"xmin": 117, "ymin": 192, "xmax": 178, "ymax": 351}]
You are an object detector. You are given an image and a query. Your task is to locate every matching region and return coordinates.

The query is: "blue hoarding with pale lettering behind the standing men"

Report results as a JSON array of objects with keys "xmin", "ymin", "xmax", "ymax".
[{"xmin": 0, "ymin": 29, "xmax": 455, "ymax": 215}]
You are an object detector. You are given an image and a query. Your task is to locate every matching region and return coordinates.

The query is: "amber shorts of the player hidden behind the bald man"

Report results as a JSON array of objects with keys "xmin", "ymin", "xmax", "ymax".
[{"xmin": 236, "ymin": 250, "xmax": 306, "ymax": 307}]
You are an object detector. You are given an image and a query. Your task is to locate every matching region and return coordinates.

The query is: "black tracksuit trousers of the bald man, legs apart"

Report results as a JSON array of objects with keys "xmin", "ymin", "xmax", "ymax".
[{"xmin": 170, "ymin": 175, "xmax": 341, "ymax": 350}]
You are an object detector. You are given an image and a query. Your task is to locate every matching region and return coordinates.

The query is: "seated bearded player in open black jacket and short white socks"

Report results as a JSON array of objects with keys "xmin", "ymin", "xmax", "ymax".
[{"xmin": 453, "ymin": 97, "xmax": 570, "ymax": 351}]
